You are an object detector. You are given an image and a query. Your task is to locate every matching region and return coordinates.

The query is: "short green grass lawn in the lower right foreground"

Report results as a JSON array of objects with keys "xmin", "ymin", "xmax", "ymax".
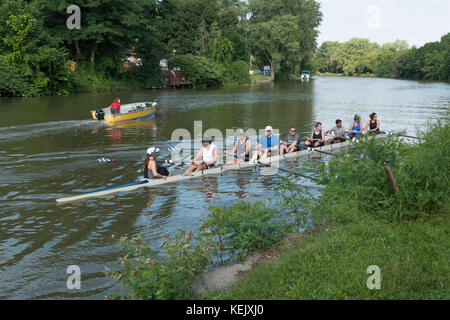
[{"xmin": 203, "ymin": 215, "xmax": 450, "ymax": 299}]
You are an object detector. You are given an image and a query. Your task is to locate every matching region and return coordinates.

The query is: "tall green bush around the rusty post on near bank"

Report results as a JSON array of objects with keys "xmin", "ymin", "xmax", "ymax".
[{"xmin": 315, "ymin": 122, "xmax": 450, "ymax": 223}]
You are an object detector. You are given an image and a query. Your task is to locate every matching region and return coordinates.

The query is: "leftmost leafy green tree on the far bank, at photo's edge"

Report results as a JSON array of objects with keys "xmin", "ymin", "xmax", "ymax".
[{"xmin": 0, "ymin": 0, "xmax": 70, "ymax": 95}]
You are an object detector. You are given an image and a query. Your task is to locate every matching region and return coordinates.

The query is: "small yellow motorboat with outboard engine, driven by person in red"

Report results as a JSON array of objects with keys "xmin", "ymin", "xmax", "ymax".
[{"xmin": 91, "ymin": 101, "xmax": 158, "ymax": 122}]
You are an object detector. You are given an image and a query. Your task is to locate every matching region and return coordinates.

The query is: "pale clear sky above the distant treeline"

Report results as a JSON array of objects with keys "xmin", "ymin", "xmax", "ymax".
[{"xmin": 317, "ymin": 0, "xmax": 450, "ymax": 47}]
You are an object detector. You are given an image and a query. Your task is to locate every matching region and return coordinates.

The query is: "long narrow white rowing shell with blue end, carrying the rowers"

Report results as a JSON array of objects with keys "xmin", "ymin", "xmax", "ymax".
[{"xmin": 56, "ymin": 129, "xmax": 406, "ymax": 203}]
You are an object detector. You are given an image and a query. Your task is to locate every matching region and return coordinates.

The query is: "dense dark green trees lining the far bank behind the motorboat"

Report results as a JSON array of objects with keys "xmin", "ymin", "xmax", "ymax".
[{"xmin": 0, "ymin": 0, "xmax": 322, "ymax": 96}]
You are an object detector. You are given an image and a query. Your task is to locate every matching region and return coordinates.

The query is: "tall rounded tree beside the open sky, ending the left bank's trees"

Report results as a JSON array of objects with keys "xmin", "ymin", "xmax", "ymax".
[{"xmin": 249, "ymin": 0, "xmax": 322, "ymax": 80}]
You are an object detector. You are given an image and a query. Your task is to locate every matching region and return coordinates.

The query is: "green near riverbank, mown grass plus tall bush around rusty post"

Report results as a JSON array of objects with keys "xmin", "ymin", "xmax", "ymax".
[{"xmin": 202, "ymin": 123, "xmax": 450, "ymax": 300}]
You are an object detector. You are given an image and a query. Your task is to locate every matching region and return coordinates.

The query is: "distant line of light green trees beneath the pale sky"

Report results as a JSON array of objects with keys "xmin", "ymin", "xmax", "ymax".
[{"xmin": 315, "ymin": 33, "xmax": 450, "ymax": 81}]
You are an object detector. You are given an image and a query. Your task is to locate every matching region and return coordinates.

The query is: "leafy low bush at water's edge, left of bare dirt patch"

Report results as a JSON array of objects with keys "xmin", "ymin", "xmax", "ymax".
[{"xmin": 105, "ymin": 230, "xmax": 212, "ymax": 300}]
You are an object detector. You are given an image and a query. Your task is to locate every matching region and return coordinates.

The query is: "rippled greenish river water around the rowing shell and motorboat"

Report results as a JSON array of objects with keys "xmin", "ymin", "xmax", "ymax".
[{"xmin": 0, "ymin": 77, "xmax": 450, "ymax": 299}]
